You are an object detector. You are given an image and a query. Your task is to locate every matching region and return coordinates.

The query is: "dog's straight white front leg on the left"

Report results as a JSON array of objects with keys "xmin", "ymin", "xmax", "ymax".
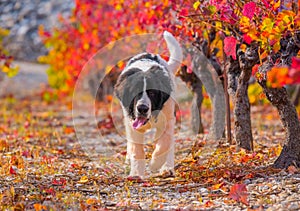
[{"xmin": 126, "ymin": 121, "xmax": 146, "ymax": 177}]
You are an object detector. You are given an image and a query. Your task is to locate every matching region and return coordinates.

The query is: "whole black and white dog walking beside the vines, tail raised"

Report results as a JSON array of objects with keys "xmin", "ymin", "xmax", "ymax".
[{"xmin": 115, "ymin": 31, "xmax": 183, "ymax": 177}]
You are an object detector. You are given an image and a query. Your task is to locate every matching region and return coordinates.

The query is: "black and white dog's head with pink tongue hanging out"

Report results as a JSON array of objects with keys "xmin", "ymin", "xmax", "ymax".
[{"xmin": 115, "ymin": 65, "xmax": 172, "ymax": 129}]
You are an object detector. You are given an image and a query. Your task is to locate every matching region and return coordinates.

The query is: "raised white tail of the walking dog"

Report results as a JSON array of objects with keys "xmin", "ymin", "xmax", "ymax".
[{"xmin": 164, "ymin": 31, "xmax": 183, "ymax": 72}]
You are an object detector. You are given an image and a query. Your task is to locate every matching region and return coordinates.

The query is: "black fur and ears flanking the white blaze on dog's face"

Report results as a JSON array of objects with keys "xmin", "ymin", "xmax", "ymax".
[{"xmin": 115, "ymin": 66, "xmax": 172, "ymax": 119}]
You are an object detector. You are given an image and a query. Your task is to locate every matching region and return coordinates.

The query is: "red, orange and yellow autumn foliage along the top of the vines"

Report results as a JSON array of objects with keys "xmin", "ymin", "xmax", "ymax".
[{"xmin": 39, "ymin": 0, "xmax": 300, "ymax": 93}]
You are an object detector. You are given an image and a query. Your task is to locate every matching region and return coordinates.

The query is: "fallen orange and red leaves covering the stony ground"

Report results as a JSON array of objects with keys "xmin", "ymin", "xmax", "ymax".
[{"xmin": 0, "ymin": 98, "xmax": 300, "ymax": 210}]
